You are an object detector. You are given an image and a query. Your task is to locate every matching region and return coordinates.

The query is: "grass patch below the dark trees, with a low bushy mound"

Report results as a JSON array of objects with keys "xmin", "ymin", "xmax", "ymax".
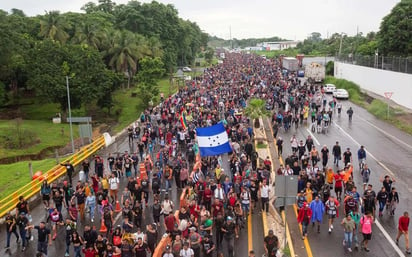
[{"xmin": 0, "ymin": 120, "xmax": 78, "ymax": 158}]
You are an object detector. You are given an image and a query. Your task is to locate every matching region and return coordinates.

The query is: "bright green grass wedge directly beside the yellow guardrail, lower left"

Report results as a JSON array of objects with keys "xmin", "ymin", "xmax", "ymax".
[{"xmin": 0, "ymin": 159, "xmax": 56, "ymax": 199}]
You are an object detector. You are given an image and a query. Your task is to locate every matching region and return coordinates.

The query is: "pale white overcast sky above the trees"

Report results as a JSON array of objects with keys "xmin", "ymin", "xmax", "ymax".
[{"xmin": 0, "ymin": 0, "xmax": 400, "ymax": 40}]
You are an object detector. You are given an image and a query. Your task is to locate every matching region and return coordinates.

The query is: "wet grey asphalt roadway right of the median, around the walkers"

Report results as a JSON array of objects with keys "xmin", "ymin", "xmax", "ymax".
[{"xmin": 279, "ymin": 94, "xmax": 412, "ymax": 257}]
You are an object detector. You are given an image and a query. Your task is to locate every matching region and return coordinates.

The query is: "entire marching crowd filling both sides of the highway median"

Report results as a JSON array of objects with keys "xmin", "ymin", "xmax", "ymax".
[{"xmin": 6, "ymin": 50, "xmax": 409, "ymax": 257}]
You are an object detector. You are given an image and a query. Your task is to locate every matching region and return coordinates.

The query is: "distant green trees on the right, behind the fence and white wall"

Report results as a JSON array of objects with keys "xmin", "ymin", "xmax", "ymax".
[{"xmin": 211, "ymin": 0, "xmax": 412, "ymax": 57}]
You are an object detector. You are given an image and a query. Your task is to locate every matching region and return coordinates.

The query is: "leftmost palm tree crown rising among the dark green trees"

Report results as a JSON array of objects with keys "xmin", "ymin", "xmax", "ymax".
[{"xmin": 39, "ymin": 11, "xmax": 70, "ymax": 43}]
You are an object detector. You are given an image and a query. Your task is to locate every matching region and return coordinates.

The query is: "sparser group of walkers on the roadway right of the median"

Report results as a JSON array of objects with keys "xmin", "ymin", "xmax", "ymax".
[{"xmin": 264, "ymin": 69, "xmax": 410, "ymax": 254}]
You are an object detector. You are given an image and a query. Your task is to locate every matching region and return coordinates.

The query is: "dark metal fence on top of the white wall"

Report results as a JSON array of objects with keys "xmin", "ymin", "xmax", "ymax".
[{"xmin": 336, "ymin": 55, "xmax": 412, "ymax": 74}]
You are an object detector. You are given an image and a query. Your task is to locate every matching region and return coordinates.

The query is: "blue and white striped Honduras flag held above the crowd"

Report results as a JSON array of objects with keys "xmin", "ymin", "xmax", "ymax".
[{"xmin": 196, "ymin": 123, "xmax": 232, "ymax": 157}]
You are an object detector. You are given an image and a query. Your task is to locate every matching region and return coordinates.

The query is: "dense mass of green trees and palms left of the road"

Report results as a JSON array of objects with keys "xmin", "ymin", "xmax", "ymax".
[{"xmin": 0, "ymin": 0, "xmax": 207, "ymax": 111}]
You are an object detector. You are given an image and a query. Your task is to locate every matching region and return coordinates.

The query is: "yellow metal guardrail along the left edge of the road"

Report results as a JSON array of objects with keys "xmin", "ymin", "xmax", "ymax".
[{"xmin": 0, "ymin": 135, "xmax": 110, "ymax": 218}]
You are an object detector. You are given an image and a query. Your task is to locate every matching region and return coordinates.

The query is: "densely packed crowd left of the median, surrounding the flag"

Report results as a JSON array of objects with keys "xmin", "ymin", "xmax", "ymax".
[{"xmin": 7, "ymin": 54, "xmax": 282, "ymax": 257}]
